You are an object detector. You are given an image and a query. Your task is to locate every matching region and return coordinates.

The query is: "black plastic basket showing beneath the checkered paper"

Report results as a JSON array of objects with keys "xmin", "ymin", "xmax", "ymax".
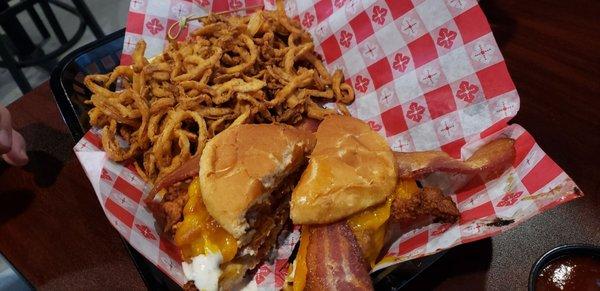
[{"xmin": 50, "ymin": 29, "xmax": 444, "ymax": 290}]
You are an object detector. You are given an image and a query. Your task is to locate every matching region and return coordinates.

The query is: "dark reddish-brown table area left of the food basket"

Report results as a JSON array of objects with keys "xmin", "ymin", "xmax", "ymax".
[{"xmin": 0, "ymin": 83, "xmax": 145, "ymax": 290}]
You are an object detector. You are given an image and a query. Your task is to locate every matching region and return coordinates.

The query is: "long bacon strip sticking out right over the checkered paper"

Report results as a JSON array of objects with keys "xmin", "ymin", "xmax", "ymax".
[{"xmin": 394, "ymin": 138, "xmax": 515, "ymax": 178}]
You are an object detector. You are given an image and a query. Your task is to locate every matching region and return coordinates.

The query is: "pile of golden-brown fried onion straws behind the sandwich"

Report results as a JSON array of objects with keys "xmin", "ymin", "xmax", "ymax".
[{"xmin": 85, "ymin": 5, "xmax": 354, "ymax": 182}]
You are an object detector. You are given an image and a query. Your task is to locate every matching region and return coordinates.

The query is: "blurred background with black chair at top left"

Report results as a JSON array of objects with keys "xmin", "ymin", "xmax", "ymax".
[{"xmin": 0, "ymin": 0, "xmax": 130, "ymax": 106}]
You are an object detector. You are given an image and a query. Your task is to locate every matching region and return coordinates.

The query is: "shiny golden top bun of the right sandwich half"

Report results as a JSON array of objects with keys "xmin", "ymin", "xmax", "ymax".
[{"xmin": 290, "ymin": 115, "xmax": 397, "ymax": 224}]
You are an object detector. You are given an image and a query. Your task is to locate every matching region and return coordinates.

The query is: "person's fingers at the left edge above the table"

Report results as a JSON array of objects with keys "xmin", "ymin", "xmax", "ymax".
[{"xmin": 0, "ymin": 104, "xmax": 29, "ymax": 166}]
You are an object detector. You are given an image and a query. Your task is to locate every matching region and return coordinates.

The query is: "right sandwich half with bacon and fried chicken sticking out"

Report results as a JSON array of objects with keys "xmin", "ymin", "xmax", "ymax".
[{"xmin": 284, "ymin": 116, "xmax": 515, "ymax": 291}]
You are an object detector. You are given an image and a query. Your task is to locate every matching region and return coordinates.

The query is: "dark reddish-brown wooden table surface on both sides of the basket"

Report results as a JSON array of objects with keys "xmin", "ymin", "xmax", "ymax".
[{"xmin": 0, "ymin": 0, "xmax": 600, "ymax": 290}]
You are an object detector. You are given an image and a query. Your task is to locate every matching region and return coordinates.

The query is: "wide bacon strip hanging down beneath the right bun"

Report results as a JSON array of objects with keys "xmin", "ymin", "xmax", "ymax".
[{"xmin": 304, "ymin": 221, "xmax": 373, "ymax": 291}]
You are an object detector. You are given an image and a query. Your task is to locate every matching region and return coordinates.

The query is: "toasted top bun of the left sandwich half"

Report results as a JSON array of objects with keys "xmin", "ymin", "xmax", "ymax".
[{"xmin": 199, "ymin": 124, "xmax": 315, "ymax": 240}]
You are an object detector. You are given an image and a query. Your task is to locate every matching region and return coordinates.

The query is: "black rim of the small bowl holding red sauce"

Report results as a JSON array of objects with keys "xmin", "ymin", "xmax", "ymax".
[{"xmin": 528, "ymin": 244, "xmax": 600, "ymax": 291}]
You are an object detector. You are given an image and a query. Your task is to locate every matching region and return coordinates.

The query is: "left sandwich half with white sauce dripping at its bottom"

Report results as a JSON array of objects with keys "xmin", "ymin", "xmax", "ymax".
[{"xmin": 174, "ymin": 124, "xmax": 315, "ymax": 290}]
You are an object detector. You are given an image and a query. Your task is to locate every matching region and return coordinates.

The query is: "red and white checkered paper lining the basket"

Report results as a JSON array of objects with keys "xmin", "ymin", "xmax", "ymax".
[{"xmin": 75, "ymin": 0, "xmax": 581, "ymax": 290}]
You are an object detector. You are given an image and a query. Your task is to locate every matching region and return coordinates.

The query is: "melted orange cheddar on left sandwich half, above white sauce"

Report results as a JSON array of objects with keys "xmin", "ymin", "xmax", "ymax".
[{"xmin": 175, "ymin": 177, "xmax": 237, "ymax": 263}]
